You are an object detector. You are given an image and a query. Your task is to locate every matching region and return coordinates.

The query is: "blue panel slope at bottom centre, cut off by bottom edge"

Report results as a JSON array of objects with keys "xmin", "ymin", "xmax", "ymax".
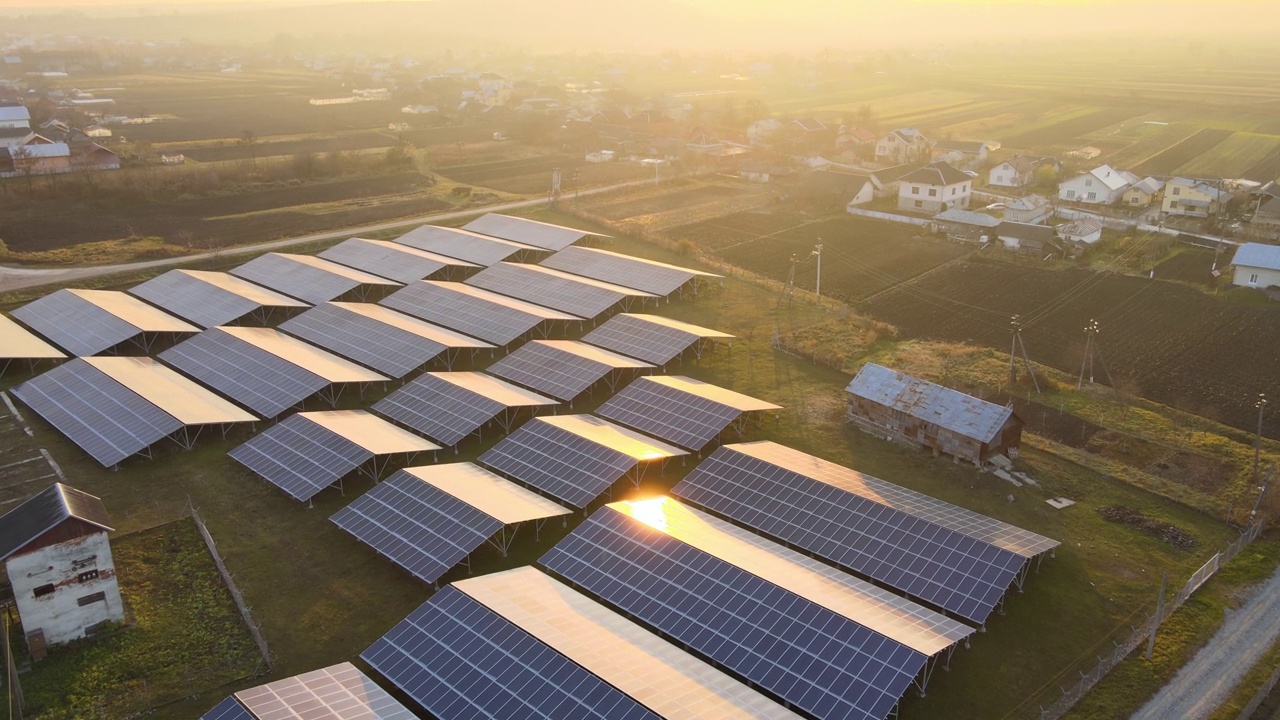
[{"xmin": 360, "ymin": 585, "xmax": 658, "ymax": 720}]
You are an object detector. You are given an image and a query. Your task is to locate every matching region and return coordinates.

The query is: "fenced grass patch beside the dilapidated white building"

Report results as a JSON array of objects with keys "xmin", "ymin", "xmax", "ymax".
[{"xmin": 15, "ymin": 520, "xmax": 261, "ymax": 720}]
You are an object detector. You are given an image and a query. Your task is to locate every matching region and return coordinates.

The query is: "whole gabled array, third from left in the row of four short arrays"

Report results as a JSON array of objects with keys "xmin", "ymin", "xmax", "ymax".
[{"xmin": 489, "ymin": 340, "xmax": 650, "ymax": 402}]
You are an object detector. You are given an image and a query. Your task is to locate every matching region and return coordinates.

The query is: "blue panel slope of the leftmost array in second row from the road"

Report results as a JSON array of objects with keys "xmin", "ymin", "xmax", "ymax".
[{"xmin": 13, "ymin": 359, "xmax": 182, "ymax": 468}]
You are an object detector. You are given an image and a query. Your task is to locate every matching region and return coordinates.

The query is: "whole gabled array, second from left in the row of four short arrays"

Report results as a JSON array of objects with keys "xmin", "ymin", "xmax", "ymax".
[{"xmin": 372, "ymin": 373, "xmax": 556, "ymax": 446}]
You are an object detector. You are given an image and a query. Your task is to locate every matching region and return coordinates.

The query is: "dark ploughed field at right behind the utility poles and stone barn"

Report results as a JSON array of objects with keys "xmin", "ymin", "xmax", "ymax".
[{"xmin": 865, "ymin": 261, "xmax": 1280, "ymax": 437}]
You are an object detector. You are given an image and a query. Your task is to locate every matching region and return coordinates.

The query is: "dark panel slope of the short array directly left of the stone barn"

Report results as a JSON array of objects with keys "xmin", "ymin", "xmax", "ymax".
[{"xmin": 595, "ymin": 378, "xmax": 742, "ymax": 451}]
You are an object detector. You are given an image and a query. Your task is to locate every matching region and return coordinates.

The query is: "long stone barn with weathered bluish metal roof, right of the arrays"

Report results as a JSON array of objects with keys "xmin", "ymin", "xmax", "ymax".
[{"xmin": 845, "ymin": 363, "xmax": 1023, "ymax": 468}]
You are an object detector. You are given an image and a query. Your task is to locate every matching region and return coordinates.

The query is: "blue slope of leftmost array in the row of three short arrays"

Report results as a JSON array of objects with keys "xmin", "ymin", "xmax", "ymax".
[{"xmin": 333, "ymin": 470, "xmax": 502, "ymax": 583}]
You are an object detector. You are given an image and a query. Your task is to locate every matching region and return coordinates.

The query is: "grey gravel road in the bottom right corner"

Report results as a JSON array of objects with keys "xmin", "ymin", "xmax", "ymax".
[{"xmin": 1130, "ymin": 561, "xmax": 1280, "ymax": 720}]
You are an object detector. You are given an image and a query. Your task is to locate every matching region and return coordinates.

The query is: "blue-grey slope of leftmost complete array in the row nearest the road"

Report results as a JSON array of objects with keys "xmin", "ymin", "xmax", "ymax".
[{"xmin": 12, "ymin": 290, "xmax": 141, "ymax": 356}]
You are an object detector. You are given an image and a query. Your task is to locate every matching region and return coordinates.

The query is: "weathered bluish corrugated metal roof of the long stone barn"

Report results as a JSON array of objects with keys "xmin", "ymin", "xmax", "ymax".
[{"xmin": 845, "ymin": 363, "xmax": 1014, "ymax": 442}]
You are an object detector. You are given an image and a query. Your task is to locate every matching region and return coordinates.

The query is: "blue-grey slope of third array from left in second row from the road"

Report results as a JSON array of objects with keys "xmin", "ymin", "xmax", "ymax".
[{"xmin": 280, "ymin": 302, "xmax": 448, "ymax": 378}]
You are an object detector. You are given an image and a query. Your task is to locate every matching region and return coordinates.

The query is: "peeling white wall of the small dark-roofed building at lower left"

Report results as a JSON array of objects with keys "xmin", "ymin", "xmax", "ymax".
[{"xmin": 5, "ymin": 533, "xmax": 124, "ymax": 644}]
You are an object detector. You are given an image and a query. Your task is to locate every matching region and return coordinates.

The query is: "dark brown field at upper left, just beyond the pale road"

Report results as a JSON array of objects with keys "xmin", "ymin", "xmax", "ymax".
[{"xmin": 0, "ymin": 173, "xmax": 449, "ymax": 252}]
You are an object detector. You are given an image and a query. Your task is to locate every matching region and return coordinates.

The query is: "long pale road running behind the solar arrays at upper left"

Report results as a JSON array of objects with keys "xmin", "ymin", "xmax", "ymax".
[{"xmin": 0, "ymin": 179, "xmax": 653, "ymax": 292}]
